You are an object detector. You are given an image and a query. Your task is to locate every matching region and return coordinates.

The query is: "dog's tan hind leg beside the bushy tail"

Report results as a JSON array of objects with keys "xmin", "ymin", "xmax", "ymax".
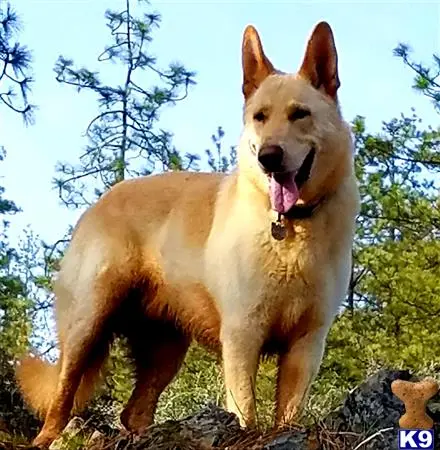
[{"xmin": 33, "ymin": 269, "xmax": 129, "ymax": 447}]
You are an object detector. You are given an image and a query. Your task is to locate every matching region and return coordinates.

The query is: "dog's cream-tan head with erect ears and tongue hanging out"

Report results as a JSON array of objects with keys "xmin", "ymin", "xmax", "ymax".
[{"xmin": 239, "ymin": 22, "xmax": 352, "ymax": 213}]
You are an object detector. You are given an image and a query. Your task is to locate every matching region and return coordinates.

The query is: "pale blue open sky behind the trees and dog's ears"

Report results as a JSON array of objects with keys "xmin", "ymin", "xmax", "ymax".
[{"xmin": 0, "ymin": 0, "xmax": 440, "ymax": 246}]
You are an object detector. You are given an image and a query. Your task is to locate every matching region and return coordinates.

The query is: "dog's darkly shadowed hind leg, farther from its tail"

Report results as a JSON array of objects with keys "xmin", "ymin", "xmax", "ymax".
[{"xmin": 121, "ymin": 319, "xmax": 189, "ymax": 434}]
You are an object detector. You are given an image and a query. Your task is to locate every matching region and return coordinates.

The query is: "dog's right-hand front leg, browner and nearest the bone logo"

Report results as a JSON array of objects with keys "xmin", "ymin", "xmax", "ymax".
[{"xmin": 275, "ymin": 327, "xmax": 328, "ymax": 426}]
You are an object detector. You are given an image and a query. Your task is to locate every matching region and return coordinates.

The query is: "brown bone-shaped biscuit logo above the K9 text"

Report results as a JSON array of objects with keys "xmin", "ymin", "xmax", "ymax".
[{"xmin": 391, "ymin": 378, "xmax": 439, "ymax": 430}]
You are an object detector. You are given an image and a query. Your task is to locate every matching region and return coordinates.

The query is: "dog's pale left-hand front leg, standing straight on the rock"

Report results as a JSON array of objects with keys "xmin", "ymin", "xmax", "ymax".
[{"xmin": 221, "ymin": 325, "xmax": 262, "ymax": 427}]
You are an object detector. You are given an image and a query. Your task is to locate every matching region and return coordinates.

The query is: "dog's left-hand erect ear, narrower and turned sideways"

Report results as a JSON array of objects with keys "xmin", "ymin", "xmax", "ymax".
[{"xmin": 242, "ymin": 25, "xmax": 275, "ymax": 100}]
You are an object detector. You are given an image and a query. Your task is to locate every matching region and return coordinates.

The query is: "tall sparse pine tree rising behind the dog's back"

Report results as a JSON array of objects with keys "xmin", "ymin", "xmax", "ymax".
[{"xmin": 55, "ymin": 0, "xmax": 197, "ymax": 207}]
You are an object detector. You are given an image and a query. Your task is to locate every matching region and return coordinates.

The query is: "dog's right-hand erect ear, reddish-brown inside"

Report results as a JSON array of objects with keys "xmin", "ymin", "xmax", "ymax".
[{"xmin": 299, "ymin": 22, "xmax": 341, "ymax": 99}]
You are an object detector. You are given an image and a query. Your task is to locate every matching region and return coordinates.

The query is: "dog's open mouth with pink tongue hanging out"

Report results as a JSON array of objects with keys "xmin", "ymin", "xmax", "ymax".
[{"xmin": 269, "ymin": 148, "xmax": 315, "ymax": 214}]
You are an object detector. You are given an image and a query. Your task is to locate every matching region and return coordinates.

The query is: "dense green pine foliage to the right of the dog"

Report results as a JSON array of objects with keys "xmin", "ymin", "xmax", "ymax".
[{"xmin": 323, "ymin": 110, "xmax": 440, "ymax": 383}]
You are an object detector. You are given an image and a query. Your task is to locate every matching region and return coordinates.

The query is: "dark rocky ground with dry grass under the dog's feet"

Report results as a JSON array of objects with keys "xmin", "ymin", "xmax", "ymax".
[{"xmin": 0, "ymin": 370, "xmax": 440, "ymax": 450}]
